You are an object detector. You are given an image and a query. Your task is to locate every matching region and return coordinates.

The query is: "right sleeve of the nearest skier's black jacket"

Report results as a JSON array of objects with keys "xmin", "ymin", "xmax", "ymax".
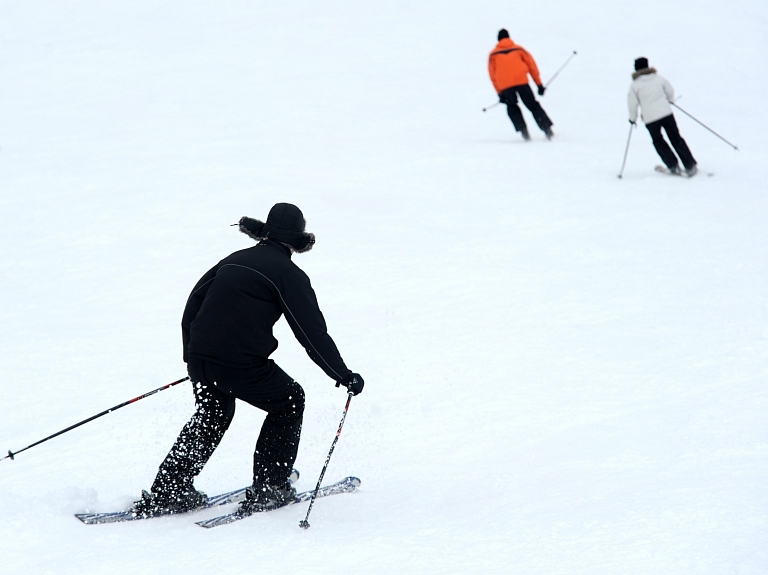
[{"xmin": 280, "ymin": 268, "xmax": 351, "ymax": 381}]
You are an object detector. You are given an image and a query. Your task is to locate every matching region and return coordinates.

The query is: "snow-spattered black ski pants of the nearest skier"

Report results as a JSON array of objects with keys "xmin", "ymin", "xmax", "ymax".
[{"xmin": 152, "ymin": 359, "xmax": 304, "ymax": 493}]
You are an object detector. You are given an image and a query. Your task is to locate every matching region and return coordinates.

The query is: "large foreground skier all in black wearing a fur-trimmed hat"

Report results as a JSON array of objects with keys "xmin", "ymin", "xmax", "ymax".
[{"xmin": 133, "ymin": 203, "xmax": 363, "ymax": 517}]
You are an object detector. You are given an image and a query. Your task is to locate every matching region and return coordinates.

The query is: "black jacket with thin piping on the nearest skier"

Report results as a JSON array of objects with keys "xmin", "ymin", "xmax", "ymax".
[{"xmin": 181, "ymin": 240, "xmax": 350, "ymax": 381}]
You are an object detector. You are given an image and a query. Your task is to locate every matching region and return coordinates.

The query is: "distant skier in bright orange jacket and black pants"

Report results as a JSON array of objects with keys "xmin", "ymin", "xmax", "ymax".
[{"xmin": 488, "ymin": 28, "xmax": 554, "ymax": 140}]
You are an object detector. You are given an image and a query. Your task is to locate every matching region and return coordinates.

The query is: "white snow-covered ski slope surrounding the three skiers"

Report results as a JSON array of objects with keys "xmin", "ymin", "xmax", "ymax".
[{"xmin": 0, "ymin": 0, "xmax": 768, "ymax": 575}]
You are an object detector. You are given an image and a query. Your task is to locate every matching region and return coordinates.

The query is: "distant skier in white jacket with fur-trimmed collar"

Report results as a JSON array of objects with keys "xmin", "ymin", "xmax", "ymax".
[{"xmin": 627, "ymin": 58, "xmax": 698, "ymax": 176}]
